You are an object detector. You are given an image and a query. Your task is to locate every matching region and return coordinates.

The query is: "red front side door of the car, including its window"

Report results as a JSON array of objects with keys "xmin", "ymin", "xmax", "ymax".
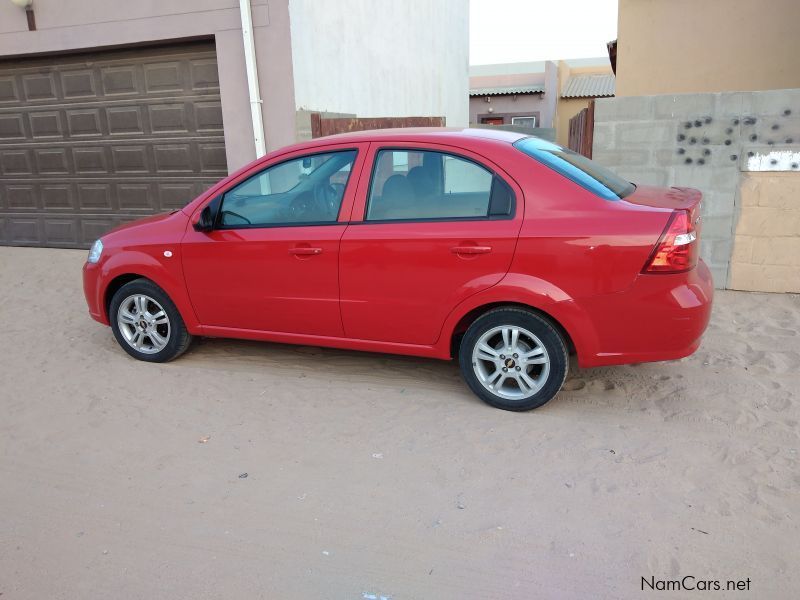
[{"xmin": 182, "ymin": 144, "xmax": 368, "ymax": 336}]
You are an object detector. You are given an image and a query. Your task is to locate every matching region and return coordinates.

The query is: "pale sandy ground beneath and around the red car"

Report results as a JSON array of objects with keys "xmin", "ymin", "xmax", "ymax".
[{"xmin": 0, "ymin": 248, "xmax": 800, "ymax": 600}]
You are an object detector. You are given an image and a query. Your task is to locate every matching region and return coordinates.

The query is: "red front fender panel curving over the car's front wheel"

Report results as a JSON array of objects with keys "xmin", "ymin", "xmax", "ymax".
[{"xmin": 98, "ymin": 244, "xmax": 200, "ymax": 335}]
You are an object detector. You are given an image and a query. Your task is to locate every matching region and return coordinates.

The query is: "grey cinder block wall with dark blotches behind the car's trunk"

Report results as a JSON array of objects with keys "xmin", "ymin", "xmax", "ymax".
[{"xmin": 592, "ymin": 89, "xmax": 800, "ymax": 287}]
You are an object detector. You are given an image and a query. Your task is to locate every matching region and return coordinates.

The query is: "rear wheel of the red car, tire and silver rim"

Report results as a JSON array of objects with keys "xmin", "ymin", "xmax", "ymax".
[{"xmin": 458, "ymin": 308, "xmax": 569, "ymax": 411}]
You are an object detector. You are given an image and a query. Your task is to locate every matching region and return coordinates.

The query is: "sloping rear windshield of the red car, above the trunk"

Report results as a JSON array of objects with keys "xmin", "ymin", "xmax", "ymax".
[{"xmin": 514, "ymin": 137, "xmax": 636, "ymax": 200}]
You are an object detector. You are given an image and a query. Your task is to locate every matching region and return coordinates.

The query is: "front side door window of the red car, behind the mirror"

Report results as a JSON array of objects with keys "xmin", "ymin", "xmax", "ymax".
[{"xmin": 219, "ymin": 150, "xmax": 356, "ymax": 229}]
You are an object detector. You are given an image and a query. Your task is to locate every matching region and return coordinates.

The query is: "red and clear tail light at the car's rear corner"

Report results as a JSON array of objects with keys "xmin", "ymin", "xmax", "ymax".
[{"xmin": 642, "ymin": 210, "xmax": 700, "ymax": 273}]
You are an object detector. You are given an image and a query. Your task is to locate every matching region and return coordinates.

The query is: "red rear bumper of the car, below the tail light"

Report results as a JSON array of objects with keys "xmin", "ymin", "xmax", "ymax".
[{"xmin": 578, "ymin": 260, "xmax": 714, "ymax": 367}]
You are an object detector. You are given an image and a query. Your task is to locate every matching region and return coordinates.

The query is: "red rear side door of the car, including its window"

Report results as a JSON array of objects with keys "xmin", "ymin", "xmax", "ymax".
[{"xmin": 340, "ymin": 143, "xmax": 524, "ymax": 345}]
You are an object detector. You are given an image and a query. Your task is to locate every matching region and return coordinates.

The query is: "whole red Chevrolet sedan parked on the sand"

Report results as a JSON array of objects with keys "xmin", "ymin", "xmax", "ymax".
[{"xmin": 83, "ymin": 129, "xmax": 713, "ymax": 410}]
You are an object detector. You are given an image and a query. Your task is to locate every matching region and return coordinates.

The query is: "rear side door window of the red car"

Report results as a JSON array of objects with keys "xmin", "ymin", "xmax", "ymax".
[{"xmin": 366, "ymin": 149, "xmax": 513, "ymax": 221}]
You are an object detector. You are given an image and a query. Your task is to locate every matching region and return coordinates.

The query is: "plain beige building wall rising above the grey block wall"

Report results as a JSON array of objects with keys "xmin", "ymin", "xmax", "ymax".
[{"xmin": 617, "ymin": 0, "xmax": 800, "ymax": 96}]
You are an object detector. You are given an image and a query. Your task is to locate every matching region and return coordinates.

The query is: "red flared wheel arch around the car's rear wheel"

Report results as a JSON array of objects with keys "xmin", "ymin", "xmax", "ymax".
[{"xmin": 436, "ymin": 273, "xmax": 598, "ymax": 366}]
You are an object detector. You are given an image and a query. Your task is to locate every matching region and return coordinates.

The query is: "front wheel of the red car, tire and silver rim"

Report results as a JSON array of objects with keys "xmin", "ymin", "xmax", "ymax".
[{"xmin": 108, "ymin": 279, "xmax": 192, "ymax": 362}]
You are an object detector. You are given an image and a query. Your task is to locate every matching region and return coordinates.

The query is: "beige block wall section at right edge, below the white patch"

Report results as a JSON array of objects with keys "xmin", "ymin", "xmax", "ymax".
[{"xmin": 729, "ymin": 172, "xmax": 800, "ymax": 292}]
